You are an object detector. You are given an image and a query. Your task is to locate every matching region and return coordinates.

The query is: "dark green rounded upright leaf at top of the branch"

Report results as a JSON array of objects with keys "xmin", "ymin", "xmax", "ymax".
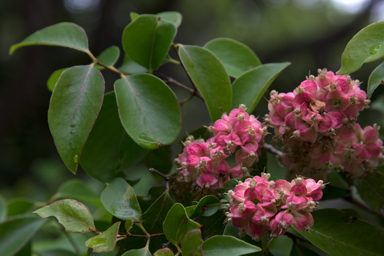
[{"xmin": 123, "ymin": 15, "xmax": 176, "ymax": 72}]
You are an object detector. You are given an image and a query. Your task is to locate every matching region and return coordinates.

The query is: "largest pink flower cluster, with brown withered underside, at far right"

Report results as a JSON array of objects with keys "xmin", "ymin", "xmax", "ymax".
[{"xmin": 265, "ymin": 69, "xmax": 383, "ymax": 179}]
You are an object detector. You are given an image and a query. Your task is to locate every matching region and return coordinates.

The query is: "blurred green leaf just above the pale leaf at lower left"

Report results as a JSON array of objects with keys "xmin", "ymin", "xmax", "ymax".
[{"xmin": 55, "ymin": 179, "xmax": 102, "ymax": 206}]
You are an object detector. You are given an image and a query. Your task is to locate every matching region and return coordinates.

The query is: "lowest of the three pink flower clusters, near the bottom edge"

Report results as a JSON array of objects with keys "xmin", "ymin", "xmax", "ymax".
[{"xmin": 226, "ymin": 173, "xmax": 325, "ymax": 241}]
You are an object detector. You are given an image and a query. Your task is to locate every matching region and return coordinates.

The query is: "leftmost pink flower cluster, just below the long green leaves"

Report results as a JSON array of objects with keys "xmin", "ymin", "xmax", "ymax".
[{"xmin": 175, "ymin": 104, "xmax": 266, "ymax": 189}]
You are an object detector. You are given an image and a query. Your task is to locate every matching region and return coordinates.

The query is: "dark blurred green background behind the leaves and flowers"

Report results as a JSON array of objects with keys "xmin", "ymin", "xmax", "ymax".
[{"xmin": 0, "ymin": 0, "xmax": 384, "ymax": 201}]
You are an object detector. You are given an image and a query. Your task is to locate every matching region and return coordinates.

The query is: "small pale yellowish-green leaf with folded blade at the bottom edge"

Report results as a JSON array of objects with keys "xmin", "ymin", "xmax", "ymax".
[{"xmin": 85, "ymin": 221, "xmax": 120, "ymax": 253}]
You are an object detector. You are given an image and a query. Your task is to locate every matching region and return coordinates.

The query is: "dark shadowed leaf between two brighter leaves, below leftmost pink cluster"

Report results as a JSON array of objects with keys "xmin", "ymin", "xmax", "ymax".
[{"xmin": 142, "ymin": 191, "xmax": 173, "ymax": 234}]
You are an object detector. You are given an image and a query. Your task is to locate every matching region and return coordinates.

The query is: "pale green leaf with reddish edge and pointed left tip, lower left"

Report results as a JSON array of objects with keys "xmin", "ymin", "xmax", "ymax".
[{"xmin": 34, "ymin": 199, "xmax": 95, "ymax": 233}]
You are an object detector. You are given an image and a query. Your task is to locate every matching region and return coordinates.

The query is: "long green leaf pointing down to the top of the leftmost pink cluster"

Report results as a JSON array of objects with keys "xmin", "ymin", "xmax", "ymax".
[{"xmin": 178, "ymin": 45, "xmax": 232, "ymax": 122}]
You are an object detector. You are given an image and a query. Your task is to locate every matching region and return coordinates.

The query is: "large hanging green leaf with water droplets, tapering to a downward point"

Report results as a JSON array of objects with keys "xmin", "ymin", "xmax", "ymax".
[{"xmin": 48, "ymin": 65, "xmax": 104, "ymax": 173}]
